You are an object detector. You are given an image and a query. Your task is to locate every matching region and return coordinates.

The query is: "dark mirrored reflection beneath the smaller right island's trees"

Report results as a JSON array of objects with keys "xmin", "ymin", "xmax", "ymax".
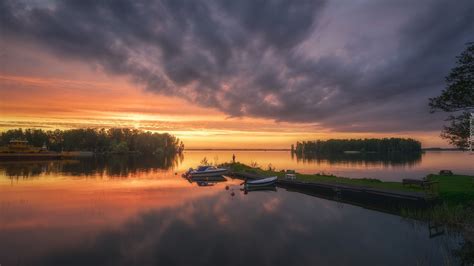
[{"xmin": 292, "ymin": 153, "xmax": 421, "ymax": 166}]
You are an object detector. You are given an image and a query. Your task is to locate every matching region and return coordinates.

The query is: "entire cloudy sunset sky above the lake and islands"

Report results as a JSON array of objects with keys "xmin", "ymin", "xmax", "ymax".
[{"xmin": 0, "ymin": 0, "xmax": 474, "ymax": 148}]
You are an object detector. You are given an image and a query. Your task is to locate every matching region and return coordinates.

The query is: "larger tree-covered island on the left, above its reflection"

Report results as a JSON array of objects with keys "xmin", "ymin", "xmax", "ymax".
[{"xmin": 0, "ymin": 128, "xmax": 184, "ymax": 155}]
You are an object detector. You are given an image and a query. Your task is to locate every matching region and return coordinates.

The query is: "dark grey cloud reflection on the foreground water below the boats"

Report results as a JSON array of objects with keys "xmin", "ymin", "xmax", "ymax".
[{"xmin": 3, "ymin": 191, "xmax": 456, "ymax": 265}]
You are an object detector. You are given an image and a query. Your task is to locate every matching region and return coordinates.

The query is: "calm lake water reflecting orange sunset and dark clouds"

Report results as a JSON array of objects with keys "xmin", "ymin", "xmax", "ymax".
[{"xmin": 0, "ymin": 151, "xmax": 474, "ymax": 266}]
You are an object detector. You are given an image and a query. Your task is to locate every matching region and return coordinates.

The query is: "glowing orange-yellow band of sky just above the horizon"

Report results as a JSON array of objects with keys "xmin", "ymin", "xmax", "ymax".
[{"xmin": 0, "ymin": 72, "xmax": 447, "ymax": 149}]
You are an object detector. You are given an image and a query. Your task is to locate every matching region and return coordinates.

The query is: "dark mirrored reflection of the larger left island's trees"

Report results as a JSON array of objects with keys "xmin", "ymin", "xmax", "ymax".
[{"xmin": 0, "ymin": 154, "xmax": 183, "ymax": 178}]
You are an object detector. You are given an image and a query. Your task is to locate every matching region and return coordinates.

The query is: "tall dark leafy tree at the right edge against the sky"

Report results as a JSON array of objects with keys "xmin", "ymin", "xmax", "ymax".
[{"xmin": 429, "ymin": 42, "xmax": 474, "ymax": 148}]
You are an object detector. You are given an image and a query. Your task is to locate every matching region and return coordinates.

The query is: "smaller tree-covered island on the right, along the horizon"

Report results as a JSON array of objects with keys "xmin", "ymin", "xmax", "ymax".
[{"xmin": 292, "ymin": 138, "xmax": 421, "ymax": 154}]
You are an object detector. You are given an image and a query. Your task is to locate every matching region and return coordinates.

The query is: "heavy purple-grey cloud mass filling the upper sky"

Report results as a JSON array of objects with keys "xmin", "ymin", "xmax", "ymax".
[{"xmin": 0, "ymin": 0, "xmax": 474, "ymax": 131}]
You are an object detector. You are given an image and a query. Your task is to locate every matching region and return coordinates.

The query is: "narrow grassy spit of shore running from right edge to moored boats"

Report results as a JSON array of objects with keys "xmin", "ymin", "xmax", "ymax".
[{"xmin": 225, "ymin": 163, "xmax": 474, "ymax": 231}]
